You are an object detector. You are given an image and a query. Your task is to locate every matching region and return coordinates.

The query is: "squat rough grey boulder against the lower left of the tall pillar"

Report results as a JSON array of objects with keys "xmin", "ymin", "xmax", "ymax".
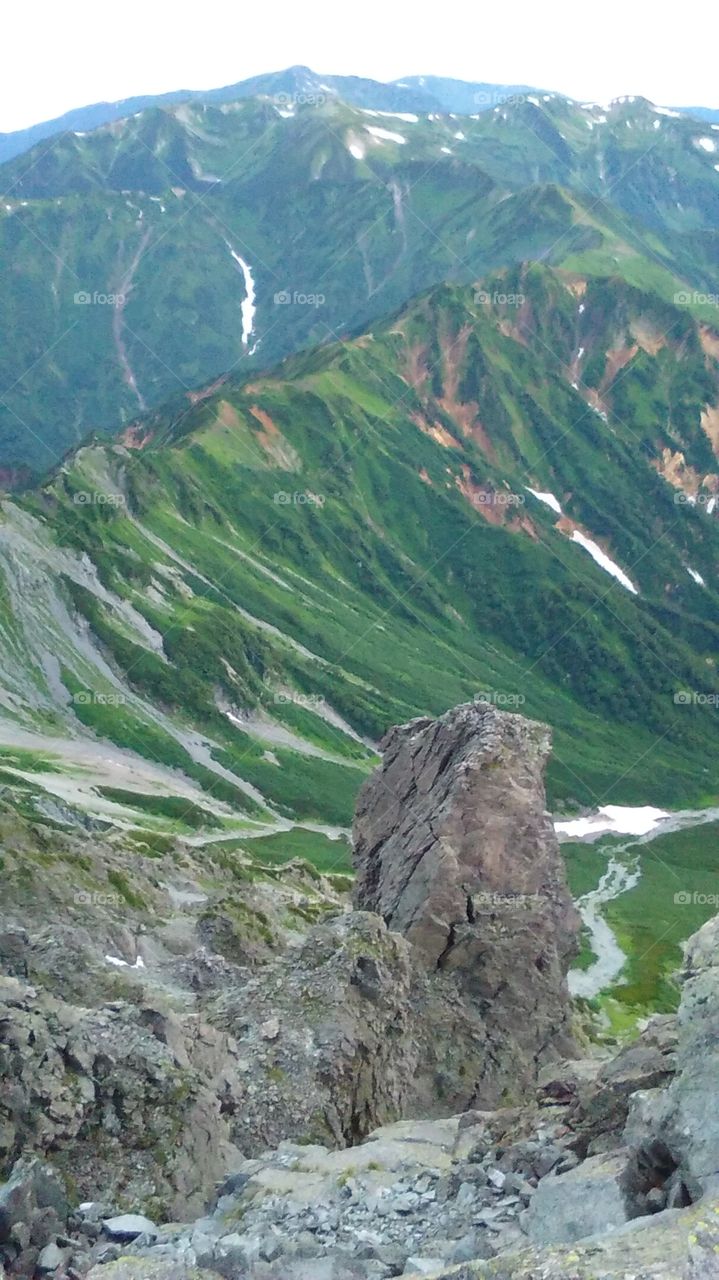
[{"xmin": 207, "ymin": 911, "xmax": 422, "ymax": 1155}]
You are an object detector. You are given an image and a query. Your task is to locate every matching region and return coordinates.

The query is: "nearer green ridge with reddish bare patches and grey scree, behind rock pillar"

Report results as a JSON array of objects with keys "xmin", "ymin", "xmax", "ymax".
[{"xmin": 0, "ymin": 266, "xmax": 719, "ymax": 840}]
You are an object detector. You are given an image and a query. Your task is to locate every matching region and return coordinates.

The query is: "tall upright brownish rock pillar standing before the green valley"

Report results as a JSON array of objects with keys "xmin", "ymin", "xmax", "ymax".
[{"xmin": 354, "ymin": 701, "xmax": 578, "ymax": 1105}]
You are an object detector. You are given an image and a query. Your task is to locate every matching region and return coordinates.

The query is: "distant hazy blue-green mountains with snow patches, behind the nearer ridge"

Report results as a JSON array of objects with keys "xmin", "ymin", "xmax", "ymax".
[{"xmin": 0, "ymin": 86, "xmax": 719, "ymax": 471}]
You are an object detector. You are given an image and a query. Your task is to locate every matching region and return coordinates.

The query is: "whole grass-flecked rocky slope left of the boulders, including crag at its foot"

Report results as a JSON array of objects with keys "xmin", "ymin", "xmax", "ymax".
[{"xmin": 0, "ymin": 822, "xmax": 350, "ymax": 1219}]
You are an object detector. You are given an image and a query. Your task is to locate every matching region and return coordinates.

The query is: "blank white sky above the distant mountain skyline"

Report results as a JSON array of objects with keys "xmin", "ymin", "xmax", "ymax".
[{"xmin": 0, "ymin": 0, "xmax": 719, "ymax": 132}]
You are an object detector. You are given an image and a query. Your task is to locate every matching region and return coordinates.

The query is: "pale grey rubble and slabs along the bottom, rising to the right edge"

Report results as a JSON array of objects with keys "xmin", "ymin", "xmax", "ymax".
[{"xmin": 26, "ymin": 916, "xmax": 719, "ymax": 1280}]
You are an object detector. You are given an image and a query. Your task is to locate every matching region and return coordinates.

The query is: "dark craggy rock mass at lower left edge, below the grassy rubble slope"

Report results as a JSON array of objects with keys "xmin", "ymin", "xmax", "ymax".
[{"xmin": 0, "ymin": 978, "xmax": 239, "ymax": 1216}]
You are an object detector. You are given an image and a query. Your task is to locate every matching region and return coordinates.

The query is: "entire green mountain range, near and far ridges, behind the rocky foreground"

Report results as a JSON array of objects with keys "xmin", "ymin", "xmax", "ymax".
[{"xmin": 0, "ymin": 70, "xmax": 719, "ymax": 858}]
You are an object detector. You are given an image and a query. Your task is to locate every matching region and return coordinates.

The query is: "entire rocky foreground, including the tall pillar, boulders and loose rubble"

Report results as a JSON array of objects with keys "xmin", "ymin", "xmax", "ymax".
[{"xmin": 0, "ymin": 704, "xmax": 719, "ymax": 1280}]
